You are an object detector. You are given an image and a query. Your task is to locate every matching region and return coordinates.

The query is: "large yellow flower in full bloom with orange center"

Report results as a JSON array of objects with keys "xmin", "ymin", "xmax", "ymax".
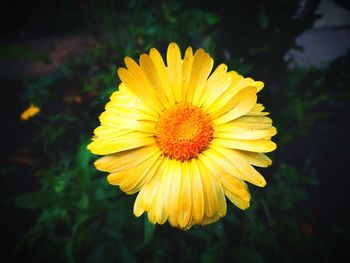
[{"xmin": 88, "ymin": 43, "xmax": 276, "ymax": 229}]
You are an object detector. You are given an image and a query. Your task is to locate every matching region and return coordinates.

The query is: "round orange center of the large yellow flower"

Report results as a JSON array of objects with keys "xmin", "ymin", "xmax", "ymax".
[{"xmin": 155, "ymin": 103, "xmax": 213, "ymax": 162}]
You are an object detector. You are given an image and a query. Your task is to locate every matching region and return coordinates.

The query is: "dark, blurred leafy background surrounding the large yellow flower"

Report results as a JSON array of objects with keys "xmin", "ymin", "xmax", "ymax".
[{"xmin": 0, "ymin": 0, "xmax": 350, "ymax": 262}]
